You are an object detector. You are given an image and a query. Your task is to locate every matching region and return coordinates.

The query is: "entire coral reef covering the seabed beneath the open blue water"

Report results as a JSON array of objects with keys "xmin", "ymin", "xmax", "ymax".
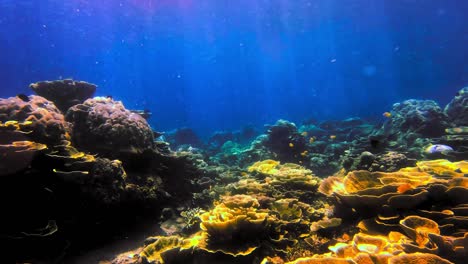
[{"xmin": 0, "ymin": 80, "xmax": 468, "ymax": 264}]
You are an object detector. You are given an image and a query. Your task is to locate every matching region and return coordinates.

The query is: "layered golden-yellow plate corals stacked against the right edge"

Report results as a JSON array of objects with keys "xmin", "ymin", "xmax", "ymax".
[{"xmin": 319, "ymin": 160, "xmax": 468, "ymax": 263}]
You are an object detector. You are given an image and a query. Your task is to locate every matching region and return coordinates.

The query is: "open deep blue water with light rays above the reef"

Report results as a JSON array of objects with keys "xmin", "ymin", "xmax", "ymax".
[{"xmin": 0, "ymin": 0, "xmax": 468, "ymax": 138}]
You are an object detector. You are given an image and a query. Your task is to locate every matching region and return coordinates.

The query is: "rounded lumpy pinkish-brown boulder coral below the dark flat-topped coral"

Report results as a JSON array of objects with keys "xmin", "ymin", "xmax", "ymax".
[{"xmin": 66, "ymin": 97, "xmax": 154, "ymax": 155}]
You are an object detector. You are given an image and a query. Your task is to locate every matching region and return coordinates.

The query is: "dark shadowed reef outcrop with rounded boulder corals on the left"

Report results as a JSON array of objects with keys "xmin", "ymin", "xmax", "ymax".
[{"xmin": 0, "ymin": 88, "xmax": 214, "ymax": 262}]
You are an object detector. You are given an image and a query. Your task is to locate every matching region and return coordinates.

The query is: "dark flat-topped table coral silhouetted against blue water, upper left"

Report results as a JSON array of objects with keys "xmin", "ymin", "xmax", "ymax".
[{"xmin": 29, "ymin": 79, "xmax": 97, "ymax": 113}]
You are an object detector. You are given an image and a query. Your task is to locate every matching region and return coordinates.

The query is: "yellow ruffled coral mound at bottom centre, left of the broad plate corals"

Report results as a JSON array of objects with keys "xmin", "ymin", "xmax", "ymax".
[{"xmin": 119, "ymin": 160, "xmax": 332, "ymax": 263}]
